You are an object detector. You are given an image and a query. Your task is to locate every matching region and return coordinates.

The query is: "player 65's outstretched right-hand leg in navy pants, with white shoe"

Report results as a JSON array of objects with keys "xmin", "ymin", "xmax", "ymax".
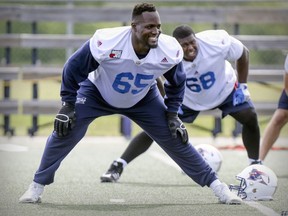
[{"xmin": 127, "ymin": 93, "xmax": 241, "ymax": 204}]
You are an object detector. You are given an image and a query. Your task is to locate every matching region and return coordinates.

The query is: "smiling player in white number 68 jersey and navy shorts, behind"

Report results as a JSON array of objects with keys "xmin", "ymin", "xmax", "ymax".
[{"xmin": 100, "ymin": 25, "xmax": 261, "ymax": 182}]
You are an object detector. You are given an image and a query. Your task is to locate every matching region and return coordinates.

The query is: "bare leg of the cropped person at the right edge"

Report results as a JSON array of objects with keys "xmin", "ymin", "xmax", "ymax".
[{"xmin": 260, "ymin": 109, "xmax": 288, "ymax": 160}]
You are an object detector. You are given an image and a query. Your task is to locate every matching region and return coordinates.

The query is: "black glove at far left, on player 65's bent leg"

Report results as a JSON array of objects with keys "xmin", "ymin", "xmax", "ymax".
[{"xmin": 54, "ymin": 102, "xmax": 76, "ymax": 137}]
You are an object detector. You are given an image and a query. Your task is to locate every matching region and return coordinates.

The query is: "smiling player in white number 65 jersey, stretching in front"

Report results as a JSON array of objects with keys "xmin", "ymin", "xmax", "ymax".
[{"xmin": 19, "ymin": 3, "xmax": 242, "ymax": 204}]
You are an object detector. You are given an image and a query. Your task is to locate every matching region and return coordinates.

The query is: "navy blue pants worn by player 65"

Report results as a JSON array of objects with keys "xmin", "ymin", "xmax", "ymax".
[{"xmin": 34, "ymin": 80, "xmax": 217, "ymax": 186}]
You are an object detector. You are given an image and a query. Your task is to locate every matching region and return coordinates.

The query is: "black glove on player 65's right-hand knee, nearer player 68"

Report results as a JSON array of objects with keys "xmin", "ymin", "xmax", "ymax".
[{"xmin": 167, "ymin": 112, "xmax": 188, "ymax": 144}]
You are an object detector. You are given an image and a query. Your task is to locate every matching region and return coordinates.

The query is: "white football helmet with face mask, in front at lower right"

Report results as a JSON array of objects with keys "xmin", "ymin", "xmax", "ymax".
[{"xmin": 229, "ymin": 164, "xmax": 278, "ymax": 200}]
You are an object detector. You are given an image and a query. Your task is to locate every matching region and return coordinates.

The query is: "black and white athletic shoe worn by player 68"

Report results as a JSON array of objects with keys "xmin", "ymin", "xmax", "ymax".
[{"xmin": 100, "ymin": 161, "xmax": 123, "ymax": 182}]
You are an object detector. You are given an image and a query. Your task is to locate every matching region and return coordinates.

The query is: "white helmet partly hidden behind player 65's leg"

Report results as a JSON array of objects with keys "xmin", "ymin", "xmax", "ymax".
[{"xmin": 195, "ymin": 144, "xmax": 223, "ymax": 172}]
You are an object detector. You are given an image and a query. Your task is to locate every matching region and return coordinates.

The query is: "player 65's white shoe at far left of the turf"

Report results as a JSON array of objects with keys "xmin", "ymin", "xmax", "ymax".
[{"xmin": 19, "ymin": 182, "xmax": 44, "ymax": 203}]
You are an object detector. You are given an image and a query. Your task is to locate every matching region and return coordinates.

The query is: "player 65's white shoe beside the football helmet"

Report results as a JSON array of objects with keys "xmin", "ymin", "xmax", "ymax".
[{"xmin": 214, "ymin": 183, "xmax": 242, "ymax": 204}]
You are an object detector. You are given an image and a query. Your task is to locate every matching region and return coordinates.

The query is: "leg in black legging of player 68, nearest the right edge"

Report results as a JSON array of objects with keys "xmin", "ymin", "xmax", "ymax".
[{"xmin": 230, "ymin": 107, "xmax": 260, "ymax": 161}]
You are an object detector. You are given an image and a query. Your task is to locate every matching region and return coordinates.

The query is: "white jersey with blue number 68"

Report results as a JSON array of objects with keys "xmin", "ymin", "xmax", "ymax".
[{"xmin": 183, "ymin": 30, "xmax": 244, "ymax": 111}]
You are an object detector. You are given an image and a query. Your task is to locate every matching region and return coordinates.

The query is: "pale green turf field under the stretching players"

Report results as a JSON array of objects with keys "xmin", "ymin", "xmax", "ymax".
[{"xmin": 0, "ymin": 137, "xmax": 288, "ymax": 216}]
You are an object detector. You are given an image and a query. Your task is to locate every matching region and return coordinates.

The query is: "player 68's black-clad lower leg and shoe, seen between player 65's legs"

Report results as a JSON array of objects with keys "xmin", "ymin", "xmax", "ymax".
[{"xmin": 100, "ymin": 131, "xmax": 153, "ymax": 182}]
